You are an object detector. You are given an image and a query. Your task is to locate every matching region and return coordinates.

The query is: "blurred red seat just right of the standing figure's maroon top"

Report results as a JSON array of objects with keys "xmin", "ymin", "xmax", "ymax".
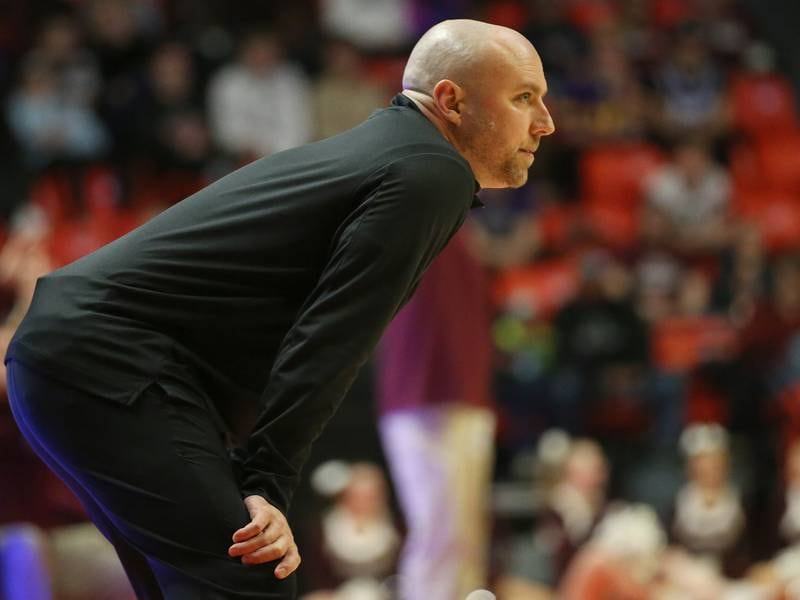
[{"xmin": 493, "ymin": 258, "xmax": 579, "ymax": 318}]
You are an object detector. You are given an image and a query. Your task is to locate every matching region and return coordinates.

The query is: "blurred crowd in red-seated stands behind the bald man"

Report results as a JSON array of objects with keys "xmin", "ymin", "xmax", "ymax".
[{"xmin": 0, "ymin": 0, "xmax": 800, "ymax": 600}]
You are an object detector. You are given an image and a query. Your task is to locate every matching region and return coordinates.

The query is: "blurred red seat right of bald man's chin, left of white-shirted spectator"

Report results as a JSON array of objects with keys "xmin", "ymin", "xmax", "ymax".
[{"xmin": 580, "ymin": 144, "xmax": 663, "ymax": 207}]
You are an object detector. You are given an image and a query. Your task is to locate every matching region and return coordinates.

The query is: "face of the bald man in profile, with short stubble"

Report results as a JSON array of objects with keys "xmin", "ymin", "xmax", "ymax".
[{"xmin": 460, "ymin": 45, "xmax": 555, "ymax": 188}]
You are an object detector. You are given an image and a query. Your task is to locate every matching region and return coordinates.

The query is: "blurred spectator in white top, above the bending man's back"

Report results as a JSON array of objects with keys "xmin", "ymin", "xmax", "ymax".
[{"xmin": 208, "ymin": 31, "xmax": 311, "ymax": 162}]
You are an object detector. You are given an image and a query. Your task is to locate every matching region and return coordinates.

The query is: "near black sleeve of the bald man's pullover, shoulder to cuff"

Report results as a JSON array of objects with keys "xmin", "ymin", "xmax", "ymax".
[{"xmin": 239, "ymin": 154, "xmax": 474, "ymax": 512}]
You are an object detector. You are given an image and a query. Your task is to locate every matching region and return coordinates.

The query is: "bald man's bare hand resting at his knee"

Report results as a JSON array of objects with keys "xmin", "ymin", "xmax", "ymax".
[{"xmin": 228, "ymin": 496, "xmax": 300, "ymax": 579}]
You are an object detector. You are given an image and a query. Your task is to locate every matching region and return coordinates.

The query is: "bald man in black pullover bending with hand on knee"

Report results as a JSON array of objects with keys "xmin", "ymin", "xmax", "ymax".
[{"xmin": 6, "ymin": 21, "xmax": 553, "ymax": 600}]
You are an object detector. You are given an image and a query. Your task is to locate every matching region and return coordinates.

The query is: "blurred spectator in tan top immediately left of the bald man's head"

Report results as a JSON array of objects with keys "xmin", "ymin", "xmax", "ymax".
[{"xmin": 313, "ymin": 40, "xmax": 386, "ymax": 139}]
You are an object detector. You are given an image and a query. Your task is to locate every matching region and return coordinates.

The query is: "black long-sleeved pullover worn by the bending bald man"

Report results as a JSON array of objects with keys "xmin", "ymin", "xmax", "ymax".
[{"xmin": 6, "ymin": 95, "xmax": 478, "ymax": 512}]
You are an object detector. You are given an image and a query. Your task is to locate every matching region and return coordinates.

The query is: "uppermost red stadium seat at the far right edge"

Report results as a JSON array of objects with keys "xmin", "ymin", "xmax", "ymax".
[{"xmin": 731, "ymin": 74, "xmax": 797, "ymax": 138}]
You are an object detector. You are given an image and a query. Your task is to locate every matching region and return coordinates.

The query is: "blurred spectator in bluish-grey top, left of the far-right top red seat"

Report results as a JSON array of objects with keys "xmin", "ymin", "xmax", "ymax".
[{"xmin": 653, "ymin": 23, "xmax": 728, "ymax": 141}]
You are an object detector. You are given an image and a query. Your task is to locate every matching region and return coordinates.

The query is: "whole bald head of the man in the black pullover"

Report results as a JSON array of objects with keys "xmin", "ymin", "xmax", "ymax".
[{"xmin": 403, "ymin": 19, "xmax": 555, "ymax": 188}]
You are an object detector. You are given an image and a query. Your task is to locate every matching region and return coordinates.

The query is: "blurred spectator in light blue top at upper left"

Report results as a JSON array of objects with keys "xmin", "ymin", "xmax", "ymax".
[{"xmin": 7, "ymin": 56, "xmax": 109, "ymax": 169}]
